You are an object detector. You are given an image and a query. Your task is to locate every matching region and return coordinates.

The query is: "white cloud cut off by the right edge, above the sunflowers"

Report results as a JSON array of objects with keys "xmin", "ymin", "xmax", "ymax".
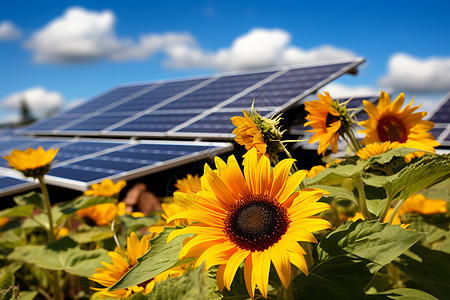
[{"xmin": 380, "ymin": 53, "xmax": 450, "ymax": 93}]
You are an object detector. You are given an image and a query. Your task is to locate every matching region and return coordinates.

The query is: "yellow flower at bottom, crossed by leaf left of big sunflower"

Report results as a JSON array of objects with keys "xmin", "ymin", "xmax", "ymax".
[{"xmin": 89, "ymin": 232, "xmax": 185, "ymax": 299}]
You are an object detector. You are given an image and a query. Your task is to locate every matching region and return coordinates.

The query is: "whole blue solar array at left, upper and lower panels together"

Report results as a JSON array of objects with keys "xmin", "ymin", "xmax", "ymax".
[{"xmin": 0, "ymin": 58, "xmax": 364, "ymax": 195}]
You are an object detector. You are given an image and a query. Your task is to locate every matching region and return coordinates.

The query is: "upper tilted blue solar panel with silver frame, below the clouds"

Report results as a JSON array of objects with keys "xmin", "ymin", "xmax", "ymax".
[{"xmin": 18, "ymin": 58, "xmax": 364, "ymax": 139}]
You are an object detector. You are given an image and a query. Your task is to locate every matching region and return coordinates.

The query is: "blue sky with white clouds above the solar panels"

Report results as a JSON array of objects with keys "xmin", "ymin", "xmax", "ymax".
[{"xmin": 0, "ymin": 0, "xmax": 450, "ymax": 123}]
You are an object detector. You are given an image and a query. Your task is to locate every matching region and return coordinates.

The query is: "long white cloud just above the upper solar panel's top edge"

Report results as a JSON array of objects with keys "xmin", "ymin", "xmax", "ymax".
[{"xmin": 165, "ymin": 28, "xmax": 355, "ymax": 71}]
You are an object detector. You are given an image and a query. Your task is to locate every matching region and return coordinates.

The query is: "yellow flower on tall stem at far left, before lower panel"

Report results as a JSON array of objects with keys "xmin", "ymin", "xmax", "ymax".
[{"xmin": 3, "ymin": 147, "xmax": 59, "ymax": 178}]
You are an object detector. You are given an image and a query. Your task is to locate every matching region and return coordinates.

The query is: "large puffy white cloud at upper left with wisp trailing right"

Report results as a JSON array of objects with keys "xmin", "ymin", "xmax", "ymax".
[{"xmin": 26, "ymin": 7, "xmax": 192, "ymax": 63}]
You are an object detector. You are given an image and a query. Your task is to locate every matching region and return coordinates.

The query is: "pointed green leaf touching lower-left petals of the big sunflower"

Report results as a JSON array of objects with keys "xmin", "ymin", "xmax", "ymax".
[{"xmin": 109, "ymin": 227, "xmax": 192, "ymax": 291}]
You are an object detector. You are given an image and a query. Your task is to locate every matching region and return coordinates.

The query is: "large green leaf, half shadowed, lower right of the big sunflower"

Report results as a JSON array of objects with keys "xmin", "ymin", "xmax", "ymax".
[{"xmin": 293, "ymin": 220, "xmax": 423, "ymax": 299}]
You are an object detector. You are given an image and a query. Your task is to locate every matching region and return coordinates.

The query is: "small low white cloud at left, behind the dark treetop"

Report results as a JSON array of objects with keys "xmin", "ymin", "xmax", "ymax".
[{"xmin": 0, "ymin": 87, "xmax": 64, "ymax": 117}]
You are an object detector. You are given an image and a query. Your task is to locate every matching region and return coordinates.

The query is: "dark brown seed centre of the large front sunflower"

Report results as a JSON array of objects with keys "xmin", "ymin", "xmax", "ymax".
[{"xmin": 224, "ymin": 195, "xmax": 290, "ymax": 251}]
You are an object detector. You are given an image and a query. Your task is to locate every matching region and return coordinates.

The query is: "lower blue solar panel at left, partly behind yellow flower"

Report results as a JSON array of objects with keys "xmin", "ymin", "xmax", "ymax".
[{"xmin": 0, "ymin": 137, "xmax": 233, "ymax": 196}]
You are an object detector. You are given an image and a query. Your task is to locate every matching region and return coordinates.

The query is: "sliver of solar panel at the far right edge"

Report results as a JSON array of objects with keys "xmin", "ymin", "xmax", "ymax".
[{"xmin": 426, "ymin": 92, "xmax": 450, "ymax": 147}]
